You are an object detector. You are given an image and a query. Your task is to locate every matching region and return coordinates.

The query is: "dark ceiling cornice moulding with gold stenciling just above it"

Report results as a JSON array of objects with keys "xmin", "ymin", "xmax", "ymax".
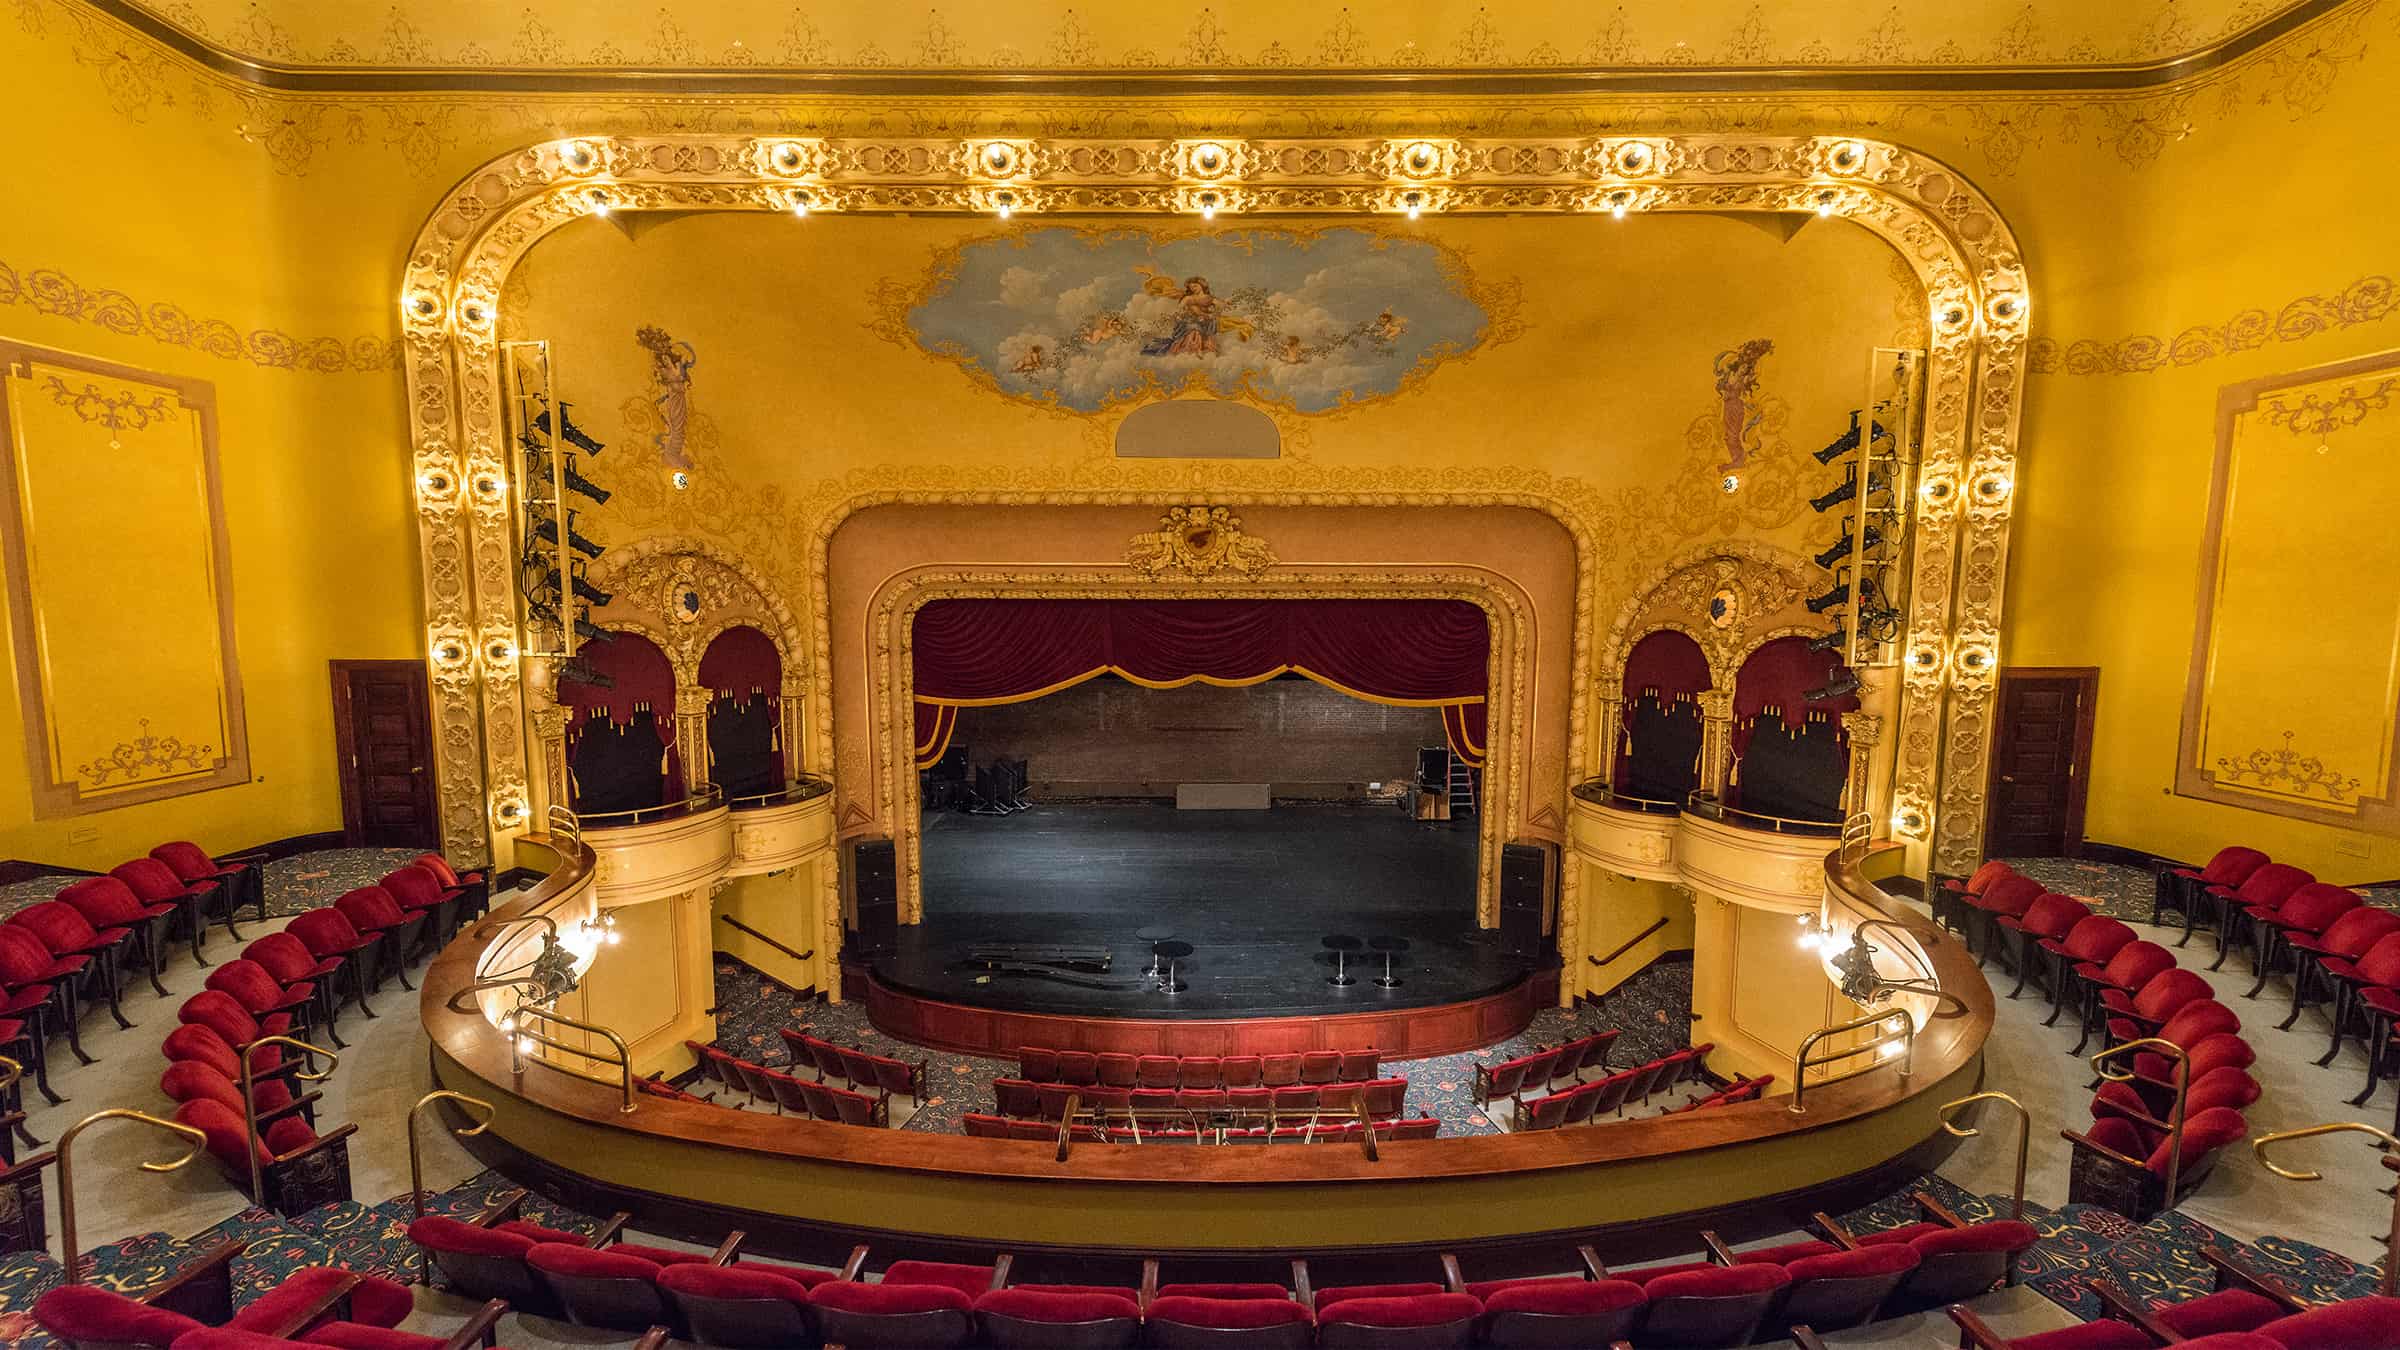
[{"xmin": 79, "ymin": 0, "xmax": 2352, "ymax": 98}]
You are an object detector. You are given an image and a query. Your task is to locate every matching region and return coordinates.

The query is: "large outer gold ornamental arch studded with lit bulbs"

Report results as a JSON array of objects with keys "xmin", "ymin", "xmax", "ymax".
[{"xmin": 401, "ymin": 135, "xmax": 2030, "ymax": 870}]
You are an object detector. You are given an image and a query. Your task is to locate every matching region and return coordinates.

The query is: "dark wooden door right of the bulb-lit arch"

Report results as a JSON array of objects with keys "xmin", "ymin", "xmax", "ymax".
[{"xmin": 1982, "ymin": 665, "xmax": 2100, "ymax": 858}]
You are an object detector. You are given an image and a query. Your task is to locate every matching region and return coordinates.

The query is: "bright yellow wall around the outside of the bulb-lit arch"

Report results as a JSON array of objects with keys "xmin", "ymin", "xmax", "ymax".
[{"xmin": 0, "ymin": 0, "xmax": 2400, "ymax": 879}]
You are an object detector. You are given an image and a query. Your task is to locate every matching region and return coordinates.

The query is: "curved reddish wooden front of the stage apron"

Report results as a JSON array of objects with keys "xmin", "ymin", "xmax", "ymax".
[{"xmin": 866, "ymin": 968, "xmax": 1558, "ymax": 1059}]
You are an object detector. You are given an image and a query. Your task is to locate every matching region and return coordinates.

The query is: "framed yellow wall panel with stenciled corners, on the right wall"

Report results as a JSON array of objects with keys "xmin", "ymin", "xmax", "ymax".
[{"xmin": 2177, "ymin": 353, "xmax": 2400, "ymax": 834}]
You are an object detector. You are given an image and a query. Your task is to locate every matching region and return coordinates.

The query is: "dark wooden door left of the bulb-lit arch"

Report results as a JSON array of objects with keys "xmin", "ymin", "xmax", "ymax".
[{"xmin": 331, "ymin": 661, "xmax": 442, "ymax": 848}]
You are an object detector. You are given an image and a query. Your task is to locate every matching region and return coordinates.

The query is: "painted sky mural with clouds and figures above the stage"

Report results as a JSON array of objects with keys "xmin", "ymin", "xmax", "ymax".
[{"xmin": 878, "ymin": 228, "xmax": 1514, "ymax": 413}]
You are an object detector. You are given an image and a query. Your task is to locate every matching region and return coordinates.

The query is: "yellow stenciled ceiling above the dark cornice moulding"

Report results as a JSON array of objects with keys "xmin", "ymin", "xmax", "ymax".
[{"xmin": 108, "ymin": 0, "xmax": 2321, "ymax": 70}]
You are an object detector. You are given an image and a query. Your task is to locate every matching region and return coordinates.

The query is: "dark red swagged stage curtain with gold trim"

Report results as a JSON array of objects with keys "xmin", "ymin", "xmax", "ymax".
[{"xmin": 914, "ymin": 601, "xmax": 1490, "ymax": 769}]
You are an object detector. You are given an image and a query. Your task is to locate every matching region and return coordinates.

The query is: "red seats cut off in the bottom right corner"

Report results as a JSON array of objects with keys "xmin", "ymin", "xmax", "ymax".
[{"xmin": 1949, "ymin": 1249, "xmax": 2400, "ymax": 1350}]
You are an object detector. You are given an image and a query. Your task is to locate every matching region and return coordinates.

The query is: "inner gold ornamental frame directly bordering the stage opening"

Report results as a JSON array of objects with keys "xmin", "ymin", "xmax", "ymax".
[{"xmin": 873, "ymin": 567, "xmax": 1526, "ymax": 951}]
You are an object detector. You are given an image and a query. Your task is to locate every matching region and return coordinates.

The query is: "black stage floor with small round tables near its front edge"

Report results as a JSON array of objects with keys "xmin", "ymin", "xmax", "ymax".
[{"xmin": 871, "ymin": 805, "xmax": 1531, "ymax": 1019}]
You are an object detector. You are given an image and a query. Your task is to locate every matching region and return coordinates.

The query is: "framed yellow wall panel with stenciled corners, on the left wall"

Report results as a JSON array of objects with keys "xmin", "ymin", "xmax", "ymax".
[{"xmin": 0, "ymin": 344, "xmax": 250, "ymax": 817}]
